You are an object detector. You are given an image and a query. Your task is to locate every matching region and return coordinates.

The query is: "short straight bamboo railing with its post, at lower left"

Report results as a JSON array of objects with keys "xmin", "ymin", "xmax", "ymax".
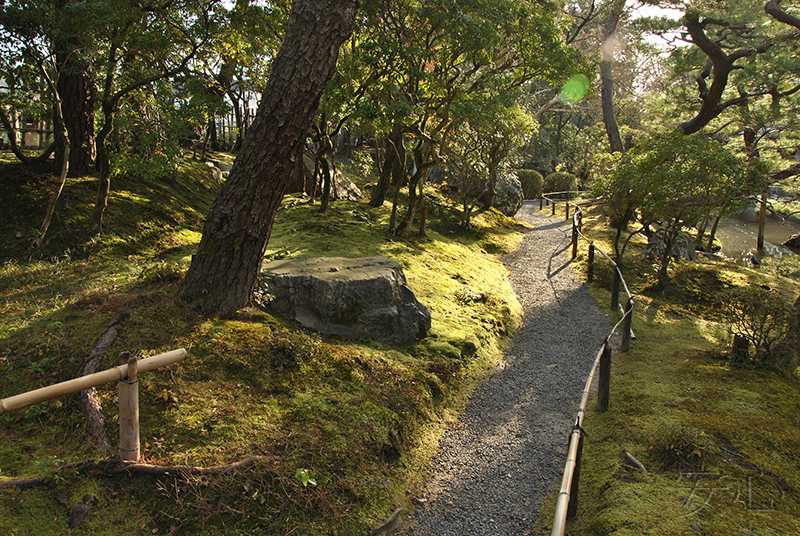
[{"xmin": 0, "ymin": 348, "xmax": 186, "ymax": 461}]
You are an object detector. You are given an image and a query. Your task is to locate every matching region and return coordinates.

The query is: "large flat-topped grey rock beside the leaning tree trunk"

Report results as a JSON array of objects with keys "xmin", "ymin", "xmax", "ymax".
[{"xmin": 260, "ymin": 257, "xmax": 431, "ymax": 344}]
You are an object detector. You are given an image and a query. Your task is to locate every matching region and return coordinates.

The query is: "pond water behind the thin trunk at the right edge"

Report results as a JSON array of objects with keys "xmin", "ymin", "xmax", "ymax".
[{"xmin": 717, "ymin": 208, "xmax": 800, "ymax": 259}]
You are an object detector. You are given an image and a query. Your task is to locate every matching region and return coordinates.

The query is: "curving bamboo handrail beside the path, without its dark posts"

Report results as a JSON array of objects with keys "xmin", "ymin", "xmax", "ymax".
[{"xmin": 542, "ymin": 202, "xmax": 633, "ymax": 536}]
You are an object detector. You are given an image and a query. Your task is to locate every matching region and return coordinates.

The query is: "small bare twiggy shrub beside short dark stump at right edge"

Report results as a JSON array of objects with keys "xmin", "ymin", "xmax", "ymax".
[{"xmin": 721, "ymin": 287, "xmax": 795, "ymax": 367}]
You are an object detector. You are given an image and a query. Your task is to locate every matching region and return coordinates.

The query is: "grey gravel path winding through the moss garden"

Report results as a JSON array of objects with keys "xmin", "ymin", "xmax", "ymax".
[{"xmin": 396, "ymin": 202, "xmax": 611, "ymax": 536}]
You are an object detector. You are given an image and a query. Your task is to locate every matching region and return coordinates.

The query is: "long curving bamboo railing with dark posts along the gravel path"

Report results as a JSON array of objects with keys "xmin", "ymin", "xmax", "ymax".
[{"xmin": 539, "ymin": 197, "xmax": 635, "ymax": 536}]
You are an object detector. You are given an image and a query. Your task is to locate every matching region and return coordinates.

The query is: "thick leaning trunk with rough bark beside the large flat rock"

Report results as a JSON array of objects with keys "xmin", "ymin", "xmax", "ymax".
[{"xmin": 179, "ymin": 0, "xmax": 357, "ymax": 316}]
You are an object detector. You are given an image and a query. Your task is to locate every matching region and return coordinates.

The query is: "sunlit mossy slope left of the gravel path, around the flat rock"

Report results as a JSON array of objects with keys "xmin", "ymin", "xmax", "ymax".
[{"xmin": 0, "ymin": 153, "xmax": 521, "ymax": 535}]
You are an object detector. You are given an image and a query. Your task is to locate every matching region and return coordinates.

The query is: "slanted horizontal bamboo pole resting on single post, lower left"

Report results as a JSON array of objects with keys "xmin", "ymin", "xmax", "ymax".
[{"xmin": 0, "ymin": 348, "xmax": 186, "ymax": 415}]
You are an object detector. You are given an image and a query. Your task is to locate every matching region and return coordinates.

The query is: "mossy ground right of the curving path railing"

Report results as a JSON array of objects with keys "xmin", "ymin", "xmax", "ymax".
[{"xmin": 542, "ymin": 203, "xmax": 800, "ymax": 536}]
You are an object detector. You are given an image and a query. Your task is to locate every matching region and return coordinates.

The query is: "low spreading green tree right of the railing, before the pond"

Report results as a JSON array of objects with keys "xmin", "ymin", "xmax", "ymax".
[{"xmin": 593, "ymin": 131, "xmax": 764, "ymax": 278}]
